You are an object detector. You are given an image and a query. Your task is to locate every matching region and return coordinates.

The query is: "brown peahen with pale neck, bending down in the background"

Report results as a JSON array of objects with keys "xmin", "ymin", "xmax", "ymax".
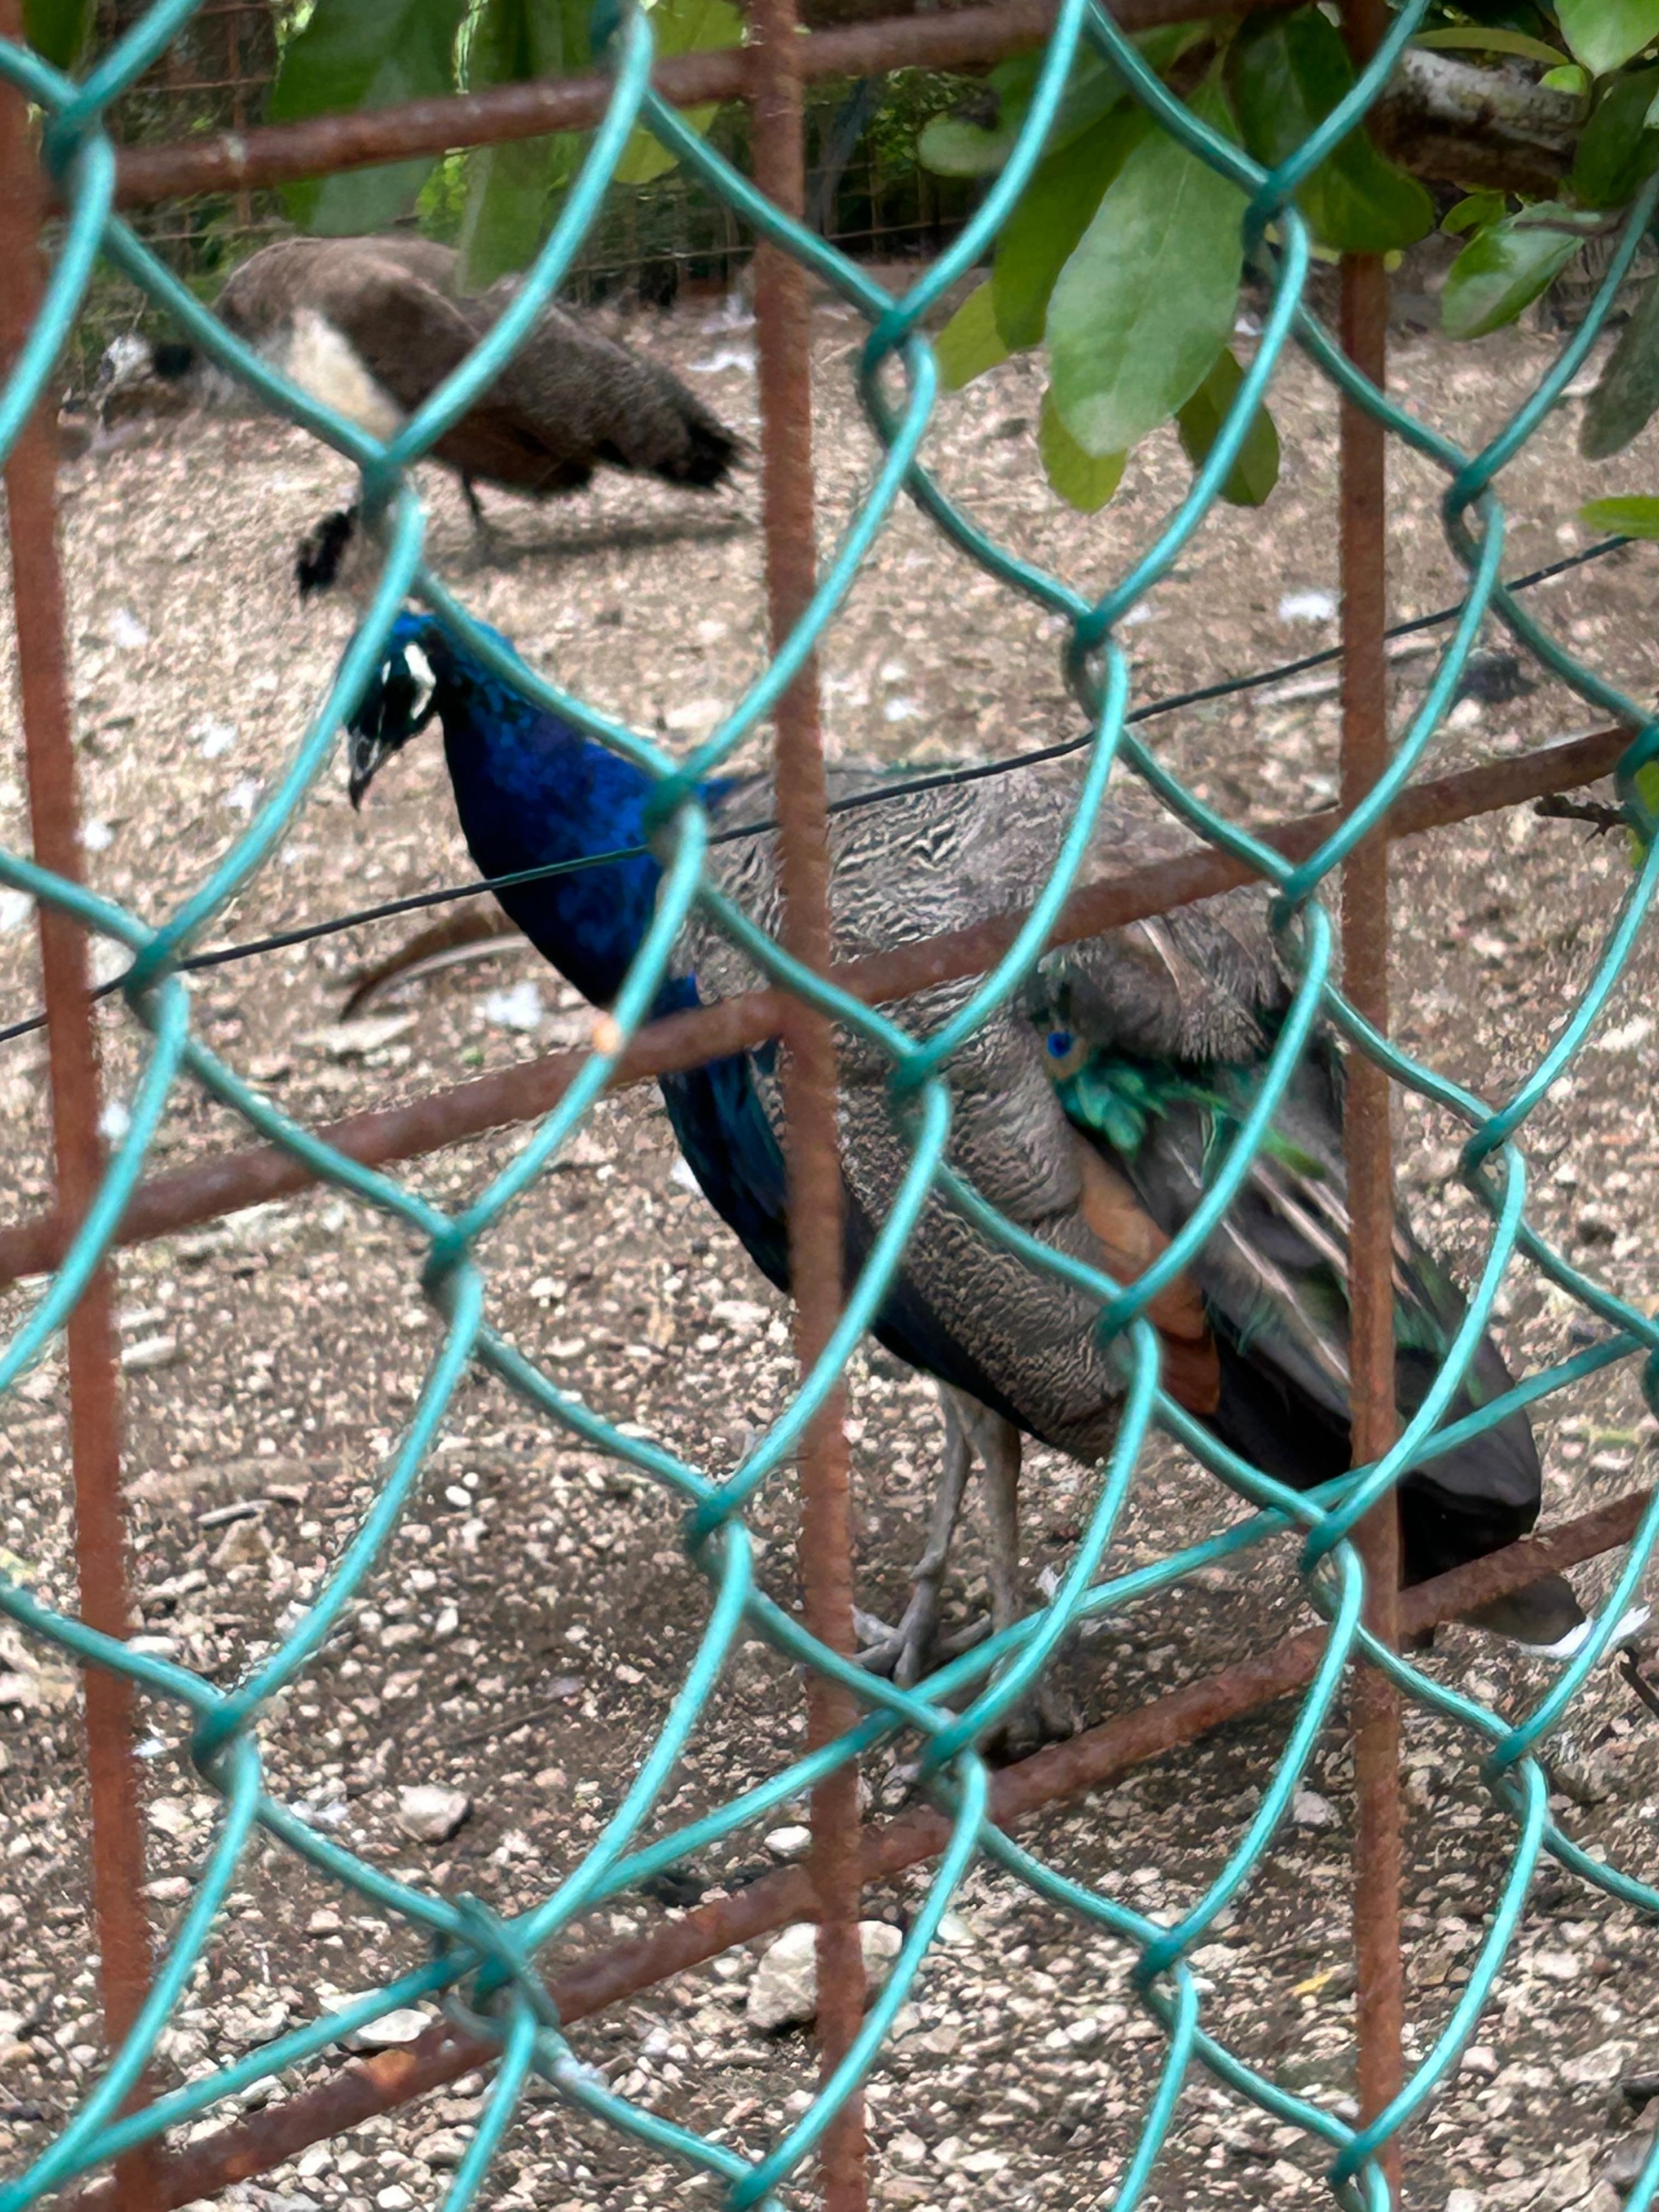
[{"xmin": 133, "ymin": 236, "xmax": 746, "ymax": 597}]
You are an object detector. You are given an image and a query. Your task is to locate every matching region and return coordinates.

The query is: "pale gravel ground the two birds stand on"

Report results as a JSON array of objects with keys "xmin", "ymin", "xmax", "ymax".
[{"xmin": 0, "ymin": 281, "xmax": 1659, "ymax": 2212}]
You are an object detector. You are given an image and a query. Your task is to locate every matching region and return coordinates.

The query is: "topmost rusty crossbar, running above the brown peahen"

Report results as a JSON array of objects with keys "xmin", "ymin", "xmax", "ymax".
[{"xmin": 115, "ymin": 0, "xmax": 1292, "ymax": 208}]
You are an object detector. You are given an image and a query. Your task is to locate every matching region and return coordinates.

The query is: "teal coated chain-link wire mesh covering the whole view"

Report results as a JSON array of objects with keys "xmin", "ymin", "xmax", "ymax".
[{"xmin": 0, "ymin": 0, "xmax": 1659, "ymax": 2212}]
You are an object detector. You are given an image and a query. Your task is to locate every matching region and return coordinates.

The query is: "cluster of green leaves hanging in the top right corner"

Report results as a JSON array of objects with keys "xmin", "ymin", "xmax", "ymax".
[{"xmin": 918, "ymin": 0, "xmax": 1659, "ymax": 506}]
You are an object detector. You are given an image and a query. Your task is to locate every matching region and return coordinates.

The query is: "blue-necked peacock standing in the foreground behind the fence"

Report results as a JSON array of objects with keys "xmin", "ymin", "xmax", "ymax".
[{"xmin": 338, "ymin": 613, "xmax": 1584, "ymax": 1725}]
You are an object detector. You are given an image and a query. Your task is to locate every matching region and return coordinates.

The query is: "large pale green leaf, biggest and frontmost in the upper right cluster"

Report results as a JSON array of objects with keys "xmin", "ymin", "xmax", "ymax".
[{"xmin": 1048, "ymin": 80, "xmax": 1245, "ymax": 458}]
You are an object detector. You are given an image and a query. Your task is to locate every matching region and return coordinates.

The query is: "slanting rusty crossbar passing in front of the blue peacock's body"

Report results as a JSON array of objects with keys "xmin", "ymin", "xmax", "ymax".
[{"xmin": 0, "ymin": 730, "xmax": 1630, "ymax": 1288}]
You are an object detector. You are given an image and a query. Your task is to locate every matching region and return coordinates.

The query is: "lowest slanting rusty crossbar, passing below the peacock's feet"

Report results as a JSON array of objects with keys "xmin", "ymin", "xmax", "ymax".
[{"xmin": 66, "ymin": 1491, "xmax": 1652, "ymax": 2212}]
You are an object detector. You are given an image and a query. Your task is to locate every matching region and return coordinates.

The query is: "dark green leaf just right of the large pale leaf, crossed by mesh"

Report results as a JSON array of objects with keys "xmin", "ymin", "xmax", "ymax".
[{"xmin": 1230, "ymin": 7, "xmax": 1434, "ymax": 255}]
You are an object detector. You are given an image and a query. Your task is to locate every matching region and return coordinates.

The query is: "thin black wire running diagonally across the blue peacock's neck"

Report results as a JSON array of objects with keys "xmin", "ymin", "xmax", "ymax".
[{"xmin": 0, "ymin": 538, "xmax": 1633, "ymax": 1044}]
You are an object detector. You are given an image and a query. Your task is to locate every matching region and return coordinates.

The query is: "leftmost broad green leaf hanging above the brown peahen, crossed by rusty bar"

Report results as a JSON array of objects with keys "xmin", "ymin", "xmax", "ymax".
[{"xmin": 268, "ymin": 0, "xmax": 467, "ymax": 236}]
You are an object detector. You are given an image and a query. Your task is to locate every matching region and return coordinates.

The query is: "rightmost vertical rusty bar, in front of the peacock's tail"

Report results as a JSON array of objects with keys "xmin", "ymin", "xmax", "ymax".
[{"xmin": 1340, "ymin": 0, "xmax": 1404, "ymax": 2205}]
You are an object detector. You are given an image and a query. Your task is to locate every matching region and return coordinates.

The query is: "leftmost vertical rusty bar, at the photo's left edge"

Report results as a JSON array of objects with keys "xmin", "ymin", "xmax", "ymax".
[{"xmin": 0, "ymin": 26, "xmax": 161, "ymax": 2212}]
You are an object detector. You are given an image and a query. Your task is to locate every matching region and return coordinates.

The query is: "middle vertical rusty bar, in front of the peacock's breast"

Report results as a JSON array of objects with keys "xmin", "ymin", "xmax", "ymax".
[{"xmin": 750, "ymin": 0, "xmax": 865, "ymax": 2212}]
